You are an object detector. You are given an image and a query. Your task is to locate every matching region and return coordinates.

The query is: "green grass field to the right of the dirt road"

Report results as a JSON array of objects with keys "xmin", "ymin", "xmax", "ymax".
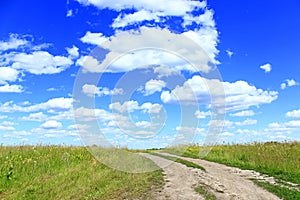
[{"xmin": 163, "ymin": 142, "xmax": 300, "ymax": 199}]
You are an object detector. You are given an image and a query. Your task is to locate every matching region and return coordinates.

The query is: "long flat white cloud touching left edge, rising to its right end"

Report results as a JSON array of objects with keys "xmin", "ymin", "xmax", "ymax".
[{"xmin": 0, "ymin": 97, "xmax": 73, "ymax": 113}]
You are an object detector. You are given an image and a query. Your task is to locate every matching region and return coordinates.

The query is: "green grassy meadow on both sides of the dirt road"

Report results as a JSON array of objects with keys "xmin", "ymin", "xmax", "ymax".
[{"xmin": 0, "ymin": 142, "xmax": 300, "ymax": 199}]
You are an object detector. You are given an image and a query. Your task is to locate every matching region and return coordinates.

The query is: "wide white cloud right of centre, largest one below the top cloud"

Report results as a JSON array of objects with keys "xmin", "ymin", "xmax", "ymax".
[{"xmin": 161, "ymin": 75, "xmax": 278, "ymax": 111}]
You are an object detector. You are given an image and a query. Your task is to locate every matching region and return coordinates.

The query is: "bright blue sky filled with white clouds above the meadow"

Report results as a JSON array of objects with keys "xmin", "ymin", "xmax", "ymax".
[{"xmin": 0, "ymin": 0, "xmax": 300, "ymax": 148}]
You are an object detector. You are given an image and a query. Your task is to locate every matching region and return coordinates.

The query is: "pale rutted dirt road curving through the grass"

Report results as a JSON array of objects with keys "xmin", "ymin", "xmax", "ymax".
[{"xmin": 142, "ymin": 153, "xmax": 279, "ymax": 200}]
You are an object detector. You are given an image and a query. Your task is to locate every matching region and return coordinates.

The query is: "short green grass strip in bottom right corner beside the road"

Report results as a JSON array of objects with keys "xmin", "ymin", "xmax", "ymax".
[{"xmin": 252, "ymin": 179, "xmax": 300, "ymax": 200}]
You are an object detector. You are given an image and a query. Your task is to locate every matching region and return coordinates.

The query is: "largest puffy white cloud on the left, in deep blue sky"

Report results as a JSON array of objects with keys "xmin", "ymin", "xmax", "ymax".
[{"xmin": 12, "ymin": 51, "xmax": 73, "ymax": 75}]
